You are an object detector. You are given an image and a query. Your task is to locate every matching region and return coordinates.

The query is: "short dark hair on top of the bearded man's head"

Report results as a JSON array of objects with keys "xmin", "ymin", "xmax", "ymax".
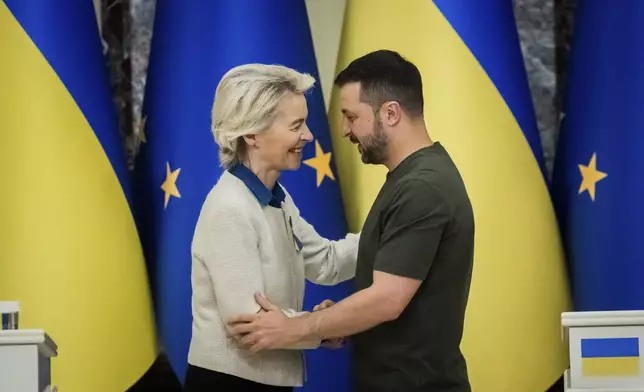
[{"xmin": 335, "ymin": 50, "xmax": 424, "ymax": 117}]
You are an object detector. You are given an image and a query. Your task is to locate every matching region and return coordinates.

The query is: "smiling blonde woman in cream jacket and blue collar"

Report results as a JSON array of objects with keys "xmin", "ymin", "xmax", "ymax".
[{"xmin": 184, "ymin": 64, "xmax": 358, "ymax": 392}]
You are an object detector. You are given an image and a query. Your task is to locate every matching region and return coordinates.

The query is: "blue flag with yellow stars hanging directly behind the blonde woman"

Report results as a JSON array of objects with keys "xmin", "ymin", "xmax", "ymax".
[{"xmin": 137, "ymin": 0, "xmax": 350, "ymax": 391}]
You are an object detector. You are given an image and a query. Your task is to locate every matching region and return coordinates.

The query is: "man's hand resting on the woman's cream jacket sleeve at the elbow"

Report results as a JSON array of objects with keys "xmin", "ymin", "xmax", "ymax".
[{"xmin": 228, "ymin": 293, "xmax": 300, "ymax": 353}]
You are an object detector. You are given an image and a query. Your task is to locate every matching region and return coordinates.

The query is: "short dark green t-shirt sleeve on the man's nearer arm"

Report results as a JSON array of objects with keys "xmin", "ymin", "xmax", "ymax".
[{"xmin": 374, "ymin": 180, "xmax": 451, "ymax": 280}]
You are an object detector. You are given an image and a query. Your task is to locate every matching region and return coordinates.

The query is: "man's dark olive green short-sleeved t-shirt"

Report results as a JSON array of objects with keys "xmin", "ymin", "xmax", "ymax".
[{"xmin": 353, "ymin": 142, "xmax": 474, "ymax": 392}]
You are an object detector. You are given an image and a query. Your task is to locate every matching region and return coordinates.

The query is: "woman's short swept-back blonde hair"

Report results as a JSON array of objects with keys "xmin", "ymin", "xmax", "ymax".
[{"xmin": 212, "ymin": 64, "xmax": 315, "ymax": 168}]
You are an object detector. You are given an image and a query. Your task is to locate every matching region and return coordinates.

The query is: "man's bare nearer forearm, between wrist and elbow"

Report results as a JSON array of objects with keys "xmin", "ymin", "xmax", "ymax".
[{"xmin": 297, "ymin": 287, "xmax": 392, "ymax": 340}]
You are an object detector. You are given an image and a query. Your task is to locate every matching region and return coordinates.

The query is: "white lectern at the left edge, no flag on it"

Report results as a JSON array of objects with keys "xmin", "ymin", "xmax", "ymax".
[{"xmin": 0, "ymin": 329, "xmax": 58, "ymax": 392}]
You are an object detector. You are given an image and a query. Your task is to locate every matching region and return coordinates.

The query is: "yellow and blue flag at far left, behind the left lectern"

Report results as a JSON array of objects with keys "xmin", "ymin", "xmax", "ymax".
[{"xmin": 0, "ymin": 0, "xmax": 156, "ymax": 392}]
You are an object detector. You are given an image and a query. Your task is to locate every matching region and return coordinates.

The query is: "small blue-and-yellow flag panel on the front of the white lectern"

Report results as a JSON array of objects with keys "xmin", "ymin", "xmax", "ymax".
[{"xmin": 581, "ymin": 337, "xmax": 640, "ymax": 377}]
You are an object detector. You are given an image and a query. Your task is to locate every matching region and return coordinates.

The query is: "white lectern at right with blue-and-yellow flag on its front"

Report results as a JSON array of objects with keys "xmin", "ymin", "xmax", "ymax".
[{"xmin": 561, "ymin": 311, "xmax": 644, "ymax": 392}]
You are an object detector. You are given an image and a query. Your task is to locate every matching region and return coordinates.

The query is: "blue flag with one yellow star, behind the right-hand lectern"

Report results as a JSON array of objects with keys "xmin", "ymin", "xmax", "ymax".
[{"xmin": 553, "ymin": 0, "xmax": 644, "ymax": 311}]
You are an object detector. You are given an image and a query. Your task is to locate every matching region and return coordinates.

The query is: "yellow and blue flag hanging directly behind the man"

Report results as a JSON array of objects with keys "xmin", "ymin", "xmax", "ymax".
[{"xmin": 331, "ymin": 0, "xmax": 569, "ymax": 392}]
